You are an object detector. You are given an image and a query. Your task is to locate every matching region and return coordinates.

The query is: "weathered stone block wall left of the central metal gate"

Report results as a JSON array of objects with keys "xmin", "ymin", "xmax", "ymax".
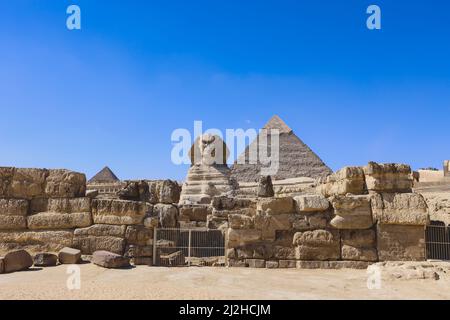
[{"xmin": 0, "ymin": 168, "xmax": 180, "ymax": 264}]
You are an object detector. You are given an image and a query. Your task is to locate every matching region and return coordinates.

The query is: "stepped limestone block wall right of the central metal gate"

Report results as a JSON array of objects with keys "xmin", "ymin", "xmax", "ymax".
[{"xmin": 227, "ymin": 162, "xmax": 429, "ymax": 268}]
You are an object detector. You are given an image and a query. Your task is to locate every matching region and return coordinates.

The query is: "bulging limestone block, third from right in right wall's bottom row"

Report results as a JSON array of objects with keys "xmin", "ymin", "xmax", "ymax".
[{"xmin": 293, "ymin": 230, "xmax": 340, "ymax": 260}]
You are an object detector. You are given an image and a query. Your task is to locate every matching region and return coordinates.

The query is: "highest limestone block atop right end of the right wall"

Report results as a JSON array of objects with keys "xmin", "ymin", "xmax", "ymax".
[{"xmin": 364, "ymin": 162, "xmax": 413, "ymax": 192}]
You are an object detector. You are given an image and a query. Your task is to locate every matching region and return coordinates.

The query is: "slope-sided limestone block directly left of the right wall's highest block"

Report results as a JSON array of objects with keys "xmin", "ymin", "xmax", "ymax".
[{"xmin": 318, "ymin": 167, "xmax": 366, "ymax": 197}]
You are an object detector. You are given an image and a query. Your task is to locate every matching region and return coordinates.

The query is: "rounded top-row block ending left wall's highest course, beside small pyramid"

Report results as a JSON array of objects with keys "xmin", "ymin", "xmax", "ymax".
[{"xmin": 45, "ymin": 169, "xmax": 86, "ymax": 198}]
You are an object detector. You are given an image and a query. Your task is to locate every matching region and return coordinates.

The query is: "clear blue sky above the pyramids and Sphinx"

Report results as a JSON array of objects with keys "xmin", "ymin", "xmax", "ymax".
[{"xmin": 0, "ymin": 0, "xmax": 450, "ymax": 179}]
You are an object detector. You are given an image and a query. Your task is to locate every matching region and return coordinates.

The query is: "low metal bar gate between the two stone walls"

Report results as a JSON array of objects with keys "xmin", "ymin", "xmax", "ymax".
[{"xmin": 153, "ymin": 228, "xmax": 225, "ymax": 267}]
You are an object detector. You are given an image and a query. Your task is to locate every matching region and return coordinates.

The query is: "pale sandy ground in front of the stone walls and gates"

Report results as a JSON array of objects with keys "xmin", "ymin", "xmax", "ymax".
[{"xmin": 0, "ymin": 264, "xmax": 450, "ymax": 300}]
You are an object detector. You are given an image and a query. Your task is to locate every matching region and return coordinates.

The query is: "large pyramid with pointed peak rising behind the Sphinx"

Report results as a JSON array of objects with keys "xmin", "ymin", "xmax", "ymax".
[{"xmin": 231, "ymin": 115, "xmax": 332, "ymax": 182}]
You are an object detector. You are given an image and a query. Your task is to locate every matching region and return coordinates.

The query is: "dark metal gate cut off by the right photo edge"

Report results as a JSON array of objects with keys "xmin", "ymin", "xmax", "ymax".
[{"xmin": 425, "ymin": 221, "xmax": 450, "ymax": 260}]
